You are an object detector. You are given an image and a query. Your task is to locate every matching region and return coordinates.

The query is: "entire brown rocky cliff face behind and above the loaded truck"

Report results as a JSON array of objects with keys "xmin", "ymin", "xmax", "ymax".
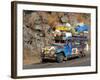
[{"xmin": 23, "ymin": 11, "xmax": 90, "ymax": 64}]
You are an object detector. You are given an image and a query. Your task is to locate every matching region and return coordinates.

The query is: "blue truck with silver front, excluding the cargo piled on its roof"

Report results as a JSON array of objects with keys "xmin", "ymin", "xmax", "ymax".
[{"xmin": 42, "ymin": 36, "xmax": 88, "ymax": 63}]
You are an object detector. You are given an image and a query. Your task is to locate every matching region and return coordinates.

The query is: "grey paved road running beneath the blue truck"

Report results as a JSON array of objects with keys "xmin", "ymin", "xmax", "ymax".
[{"xmin": 23, "ymin": 54, "xmax": 91, "ymax": 69}]
